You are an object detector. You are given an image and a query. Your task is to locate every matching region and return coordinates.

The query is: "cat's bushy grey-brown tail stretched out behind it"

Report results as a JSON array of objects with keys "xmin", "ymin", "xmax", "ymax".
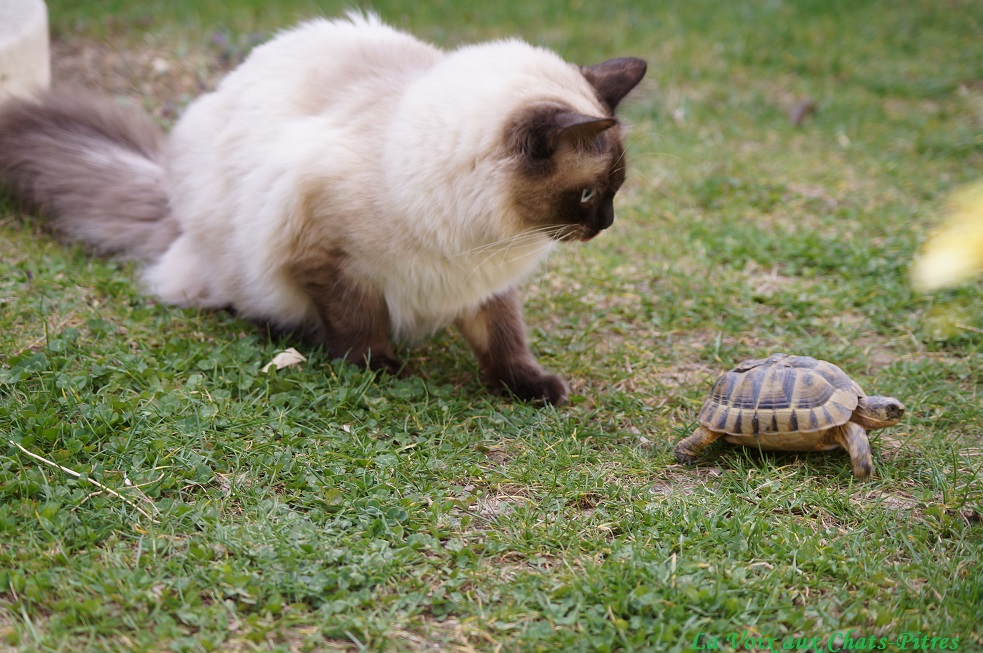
[{"xmin": 0, "ymin": 91, "xmax": 179, "ymax": 260}]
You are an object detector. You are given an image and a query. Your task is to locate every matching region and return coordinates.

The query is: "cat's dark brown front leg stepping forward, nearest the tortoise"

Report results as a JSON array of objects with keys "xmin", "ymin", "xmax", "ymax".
[{"xmin": 455, "ymin": 290, "xmax": 570, "ymax": 406}]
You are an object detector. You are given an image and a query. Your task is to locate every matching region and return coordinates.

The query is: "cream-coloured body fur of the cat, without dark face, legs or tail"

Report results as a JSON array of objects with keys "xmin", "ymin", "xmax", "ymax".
[{"xmin": 144, "ymin": 14, "xmax": 607, "ymax": 338}]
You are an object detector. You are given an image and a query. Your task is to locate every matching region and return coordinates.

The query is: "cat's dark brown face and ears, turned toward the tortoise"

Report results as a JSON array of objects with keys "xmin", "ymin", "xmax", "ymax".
[{"xmin": 506, "ymin": 59, "xmax": 645, "ymax": 241}]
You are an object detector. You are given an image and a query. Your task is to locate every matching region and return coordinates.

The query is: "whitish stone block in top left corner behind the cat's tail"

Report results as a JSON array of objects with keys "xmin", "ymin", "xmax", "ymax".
[{"xmin": 0, "ymin": 0, "xmax": 51, "ymax": 100}]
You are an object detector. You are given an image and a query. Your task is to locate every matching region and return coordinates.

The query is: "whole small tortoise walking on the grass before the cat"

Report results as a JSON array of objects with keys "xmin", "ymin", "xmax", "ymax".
[{"xmin": 675, "ymin": 354, "xmax": 905, "ymax": 479}]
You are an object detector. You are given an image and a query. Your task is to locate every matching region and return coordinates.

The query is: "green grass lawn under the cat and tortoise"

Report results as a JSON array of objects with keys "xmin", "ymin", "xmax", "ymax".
[{"xmin": 0, "ymin": 0, "xmax": 983, "ymax": 652}]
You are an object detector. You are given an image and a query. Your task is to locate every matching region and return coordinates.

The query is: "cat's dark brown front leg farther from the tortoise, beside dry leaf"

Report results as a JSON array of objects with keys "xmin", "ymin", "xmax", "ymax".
[{"xmin": 291, "ymin": 258, "xmax": 402, "ymax": 374}]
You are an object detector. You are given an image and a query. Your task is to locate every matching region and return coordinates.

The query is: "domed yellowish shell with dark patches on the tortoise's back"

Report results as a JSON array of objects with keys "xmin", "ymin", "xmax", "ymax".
[{"xmin": 699, "ymin": 354, "xmax": 864, "ymax": 435}]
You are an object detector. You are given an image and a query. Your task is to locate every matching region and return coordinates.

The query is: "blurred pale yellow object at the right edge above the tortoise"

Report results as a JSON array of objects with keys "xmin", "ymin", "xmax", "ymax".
[{"xmin": 911, "ymin": 183, "xmax": 983, "ymax": 292}]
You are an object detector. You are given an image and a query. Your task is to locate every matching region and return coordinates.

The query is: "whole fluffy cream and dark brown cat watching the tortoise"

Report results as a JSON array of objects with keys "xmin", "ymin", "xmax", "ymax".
[{"xmin": 0, "ymin": 13, "xmax": 646, "ymax": 405}]
